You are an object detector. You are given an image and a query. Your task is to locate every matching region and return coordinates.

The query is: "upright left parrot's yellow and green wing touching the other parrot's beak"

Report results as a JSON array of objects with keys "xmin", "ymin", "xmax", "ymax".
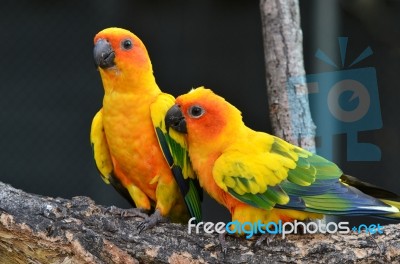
[{"xmin": 150, "ymin": 93, "xmax": 202, "ymax": 222}]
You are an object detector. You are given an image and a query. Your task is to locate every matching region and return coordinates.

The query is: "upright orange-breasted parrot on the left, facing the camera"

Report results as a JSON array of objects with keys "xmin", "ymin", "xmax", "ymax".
[{"xmin": 90, "ymin": 28, "xmax": 201, "ymax": 230}]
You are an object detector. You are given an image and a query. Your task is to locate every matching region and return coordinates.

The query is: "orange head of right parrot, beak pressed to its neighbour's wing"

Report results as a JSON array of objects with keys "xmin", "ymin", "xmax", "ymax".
[{"xmin": 165, "ymin": 87, "xmax": 243, "ymax": 144}]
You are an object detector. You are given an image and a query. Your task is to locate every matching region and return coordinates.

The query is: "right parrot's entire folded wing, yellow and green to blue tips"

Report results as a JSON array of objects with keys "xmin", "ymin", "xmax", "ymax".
[{"xmin": 213, "ymin": 132, "xmax": 398, "ymax": 218}]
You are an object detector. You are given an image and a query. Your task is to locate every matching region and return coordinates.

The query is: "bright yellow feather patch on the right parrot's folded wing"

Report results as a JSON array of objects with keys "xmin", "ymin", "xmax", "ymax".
[{"xmin": 213, "ymin": 131, "xmax": 298, "ymax": 195}]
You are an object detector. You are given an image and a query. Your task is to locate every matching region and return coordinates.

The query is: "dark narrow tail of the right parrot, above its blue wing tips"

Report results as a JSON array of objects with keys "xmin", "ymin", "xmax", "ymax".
[{"xmin": 340, "ymin": 174, "xmax": 400, "ymax": 219}]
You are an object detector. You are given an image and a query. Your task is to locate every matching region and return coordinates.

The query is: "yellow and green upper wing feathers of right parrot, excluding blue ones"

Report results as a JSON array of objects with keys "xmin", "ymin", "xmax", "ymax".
[{"xmin": 213, "ymin": 132, "xmax": 334, "ymax": 210}]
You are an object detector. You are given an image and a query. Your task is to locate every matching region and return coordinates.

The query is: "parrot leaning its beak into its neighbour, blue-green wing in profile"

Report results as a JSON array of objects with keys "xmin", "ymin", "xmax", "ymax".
[{"xmin": 165, "ymin": 87, "xmax": 400, "ymax": 236}]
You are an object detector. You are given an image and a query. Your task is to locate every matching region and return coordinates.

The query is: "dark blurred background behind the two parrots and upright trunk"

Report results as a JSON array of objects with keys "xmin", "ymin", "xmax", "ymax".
[{"xmin": 0, "ymin": 0, "xmax": 400, "ymax": 226}]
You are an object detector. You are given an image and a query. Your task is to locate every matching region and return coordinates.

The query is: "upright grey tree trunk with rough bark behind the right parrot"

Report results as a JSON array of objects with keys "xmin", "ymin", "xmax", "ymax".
[{"xmin": 260, "ymin": 0, "xmax": 315, "ymax": 152}]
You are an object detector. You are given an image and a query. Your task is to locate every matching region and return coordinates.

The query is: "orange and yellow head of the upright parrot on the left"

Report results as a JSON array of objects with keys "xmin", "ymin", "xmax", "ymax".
[{"xmin": 93, "ymin": 27, "xmax": 153, "ymax": 89}]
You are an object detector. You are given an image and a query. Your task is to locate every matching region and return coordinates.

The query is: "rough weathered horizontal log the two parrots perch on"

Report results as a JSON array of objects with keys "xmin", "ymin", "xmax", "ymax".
[{"xmin": 0, "ymin": 183, "xmax": 400, "ymax": 263}]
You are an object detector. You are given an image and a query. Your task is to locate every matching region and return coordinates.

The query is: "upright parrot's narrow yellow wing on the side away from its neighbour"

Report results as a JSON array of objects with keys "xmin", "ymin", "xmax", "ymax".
[{"xmin": 90, "ymin": 109, "xmax": 135, "ymax": 207}]
